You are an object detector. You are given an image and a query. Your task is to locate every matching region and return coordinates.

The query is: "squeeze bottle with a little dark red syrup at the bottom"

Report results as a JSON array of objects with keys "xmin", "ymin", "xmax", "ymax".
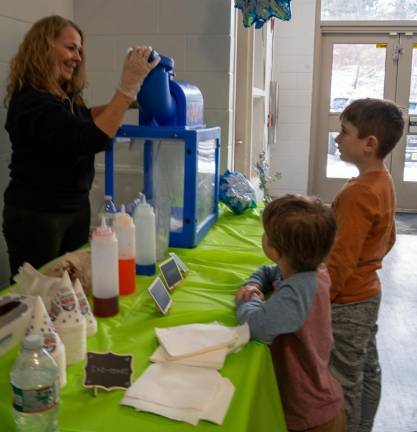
[{"xmin": 91, "ymin": 217, "xmax": 119, "ymax": 317}]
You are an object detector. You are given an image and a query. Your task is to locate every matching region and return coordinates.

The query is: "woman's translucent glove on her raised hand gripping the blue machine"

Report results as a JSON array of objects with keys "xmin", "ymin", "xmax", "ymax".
[{"xmin": 117, "ymin": 46, "xmax": 160, "ymax": 100}]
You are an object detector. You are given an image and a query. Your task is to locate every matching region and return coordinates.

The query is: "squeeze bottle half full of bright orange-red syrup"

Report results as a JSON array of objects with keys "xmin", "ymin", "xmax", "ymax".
[{"xmin": 113, "ymin": 204, "xmax": 136, "ymax": 295}]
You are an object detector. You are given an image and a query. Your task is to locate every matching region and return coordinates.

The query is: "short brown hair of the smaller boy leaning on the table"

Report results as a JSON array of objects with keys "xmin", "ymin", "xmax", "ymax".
[{"xmin": 262, "ymin": 195, "xmax": 336, "ymax": 272}]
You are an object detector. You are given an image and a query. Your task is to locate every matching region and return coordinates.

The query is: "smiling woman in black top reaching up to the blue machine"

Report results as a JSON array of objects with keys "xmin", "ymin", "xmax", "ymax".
[{"xmin": 3, "ymin": 15, "xmax": 159, "ymax": 275}]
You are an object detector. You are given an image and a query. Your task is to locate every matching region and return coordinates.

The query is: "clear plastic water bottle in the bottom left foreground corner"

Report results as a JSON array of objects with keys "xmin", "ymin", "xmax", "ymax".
[{"xmin": 10, "ymin": 335, "xmax": 59, "ymax": 432}]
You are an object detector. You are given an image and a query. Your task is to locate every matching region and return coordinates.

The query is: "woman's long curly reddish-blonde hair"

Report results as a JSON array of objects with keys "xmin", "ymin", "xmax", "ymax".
[{"xmin": 4, "ymin": 15, "xmax": 86, "ymax": 107}]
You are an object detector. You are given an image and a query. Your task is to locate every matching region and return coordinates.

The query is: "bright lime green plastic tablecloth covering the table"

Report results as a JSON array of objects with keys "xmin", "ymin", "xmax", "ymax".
[{"xmin": 0, "ymin": 208, "xmax": 286, "ymax": 432}]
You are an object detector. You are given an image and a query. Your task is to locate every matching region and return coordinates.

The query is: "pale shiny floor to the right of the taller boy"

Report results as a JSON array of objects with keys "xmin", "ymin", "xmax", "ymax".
[{"xmin": 373, "ymin": 235, "xmax": 417, "ymax": 432}]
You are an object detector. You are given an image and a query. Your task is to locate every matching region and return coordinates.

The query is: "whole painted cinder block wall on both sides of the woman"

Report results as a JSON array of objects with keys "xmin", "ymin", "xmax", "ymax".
[{"xmin": 0, "ymin": 0, "xmax": 234, "ymax": 287}]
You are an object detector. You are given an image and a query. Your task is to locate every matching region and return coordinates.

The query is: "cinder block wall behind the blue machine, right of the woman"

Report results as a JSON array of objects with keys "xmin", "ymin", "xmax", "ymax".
[{"xmin": 74, "ymin": 0, "xmax": 234, "ymax": 223}]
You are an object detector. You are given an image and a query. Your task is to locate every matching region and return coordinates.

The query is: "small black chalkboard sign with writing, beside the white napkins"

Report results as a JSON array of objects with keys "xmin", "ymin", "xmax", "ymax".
[{"xmin": 83, "ymin": 352, "xmax": 133, "ymax": 390}]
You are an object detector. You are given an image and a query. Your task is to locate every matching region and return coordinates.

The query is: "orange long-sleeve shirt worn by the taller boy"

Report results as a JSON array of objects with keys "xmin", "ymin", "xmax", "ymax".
[{"xmin": 326, "ymin": 170, "xmax": 396, "ymax": 303}]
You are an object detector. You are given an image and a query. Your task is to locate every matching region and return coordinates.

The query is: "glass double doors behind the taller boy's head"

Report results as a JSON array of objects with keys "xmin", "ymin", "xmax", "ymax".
[{"xmin": 312, "ymin": 32, "xmax": 417, "ymax": 209}]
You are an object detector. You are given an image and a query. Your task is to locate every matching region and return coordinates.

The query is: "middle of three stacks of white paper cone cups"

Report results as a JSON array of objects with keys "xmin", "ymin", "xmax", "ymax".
[{"xmin": 49, "ymin": 272, "xmax": 87, "ymax": 364}]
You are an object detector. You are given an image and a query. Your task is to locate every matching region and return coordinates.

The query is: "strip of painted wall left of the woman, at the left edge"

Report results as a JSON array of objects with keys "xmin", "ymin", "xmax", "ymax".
[{"xmin": 0, "ymin": 0, "xmax": 74, "ymax": 289}]
